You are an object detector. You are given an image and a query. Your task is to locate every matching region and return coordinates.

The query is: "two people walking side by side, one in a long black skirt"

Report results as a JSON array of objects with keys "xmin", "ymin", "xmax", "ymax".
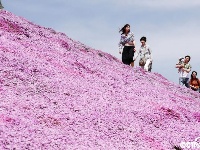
[{"xmin": 119, "ymin": 24, "xmax": 153, "ymax": 71}]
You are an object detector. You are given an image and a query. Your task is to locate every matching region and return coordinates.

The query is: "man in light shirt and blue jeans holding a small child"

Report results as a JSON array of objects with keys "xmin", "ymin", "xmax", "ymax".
[{"xmin": 176, "ymin": 55, "xmax": 192, "ymax": 88}]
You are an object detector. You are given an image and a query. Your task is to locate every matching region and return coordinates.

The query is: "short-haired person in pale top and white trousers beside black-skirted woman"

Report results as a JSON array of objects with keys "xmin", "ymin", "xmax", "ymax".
[{"xmin": 135, "ymin": 36, "xmax": 153, "ymax": 72}]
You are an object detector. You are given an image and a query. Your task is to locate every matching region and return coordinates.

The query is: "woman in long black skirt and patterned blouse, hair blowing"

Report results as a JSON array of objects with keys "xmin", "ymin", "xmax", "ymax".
[{"xmin": 119, "ymin": 24, "xmax": 135, "ymax": 67}]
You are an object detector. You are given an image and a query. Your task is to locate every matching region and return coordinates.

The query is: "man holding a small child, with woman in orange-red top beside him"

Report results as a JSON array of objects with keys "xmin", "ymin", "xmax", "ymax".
[{"xmin": 175, "ymin": 55, "xmax": 200, "ymax": 92}]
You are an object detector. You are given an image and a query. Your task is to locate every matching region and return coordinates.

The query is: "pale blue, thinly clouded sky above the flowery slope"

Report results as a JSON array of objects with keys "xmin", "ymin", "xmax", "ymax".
[{"xmin": 1, "ymin": 0, "xmax": 200, "ymax": 83}]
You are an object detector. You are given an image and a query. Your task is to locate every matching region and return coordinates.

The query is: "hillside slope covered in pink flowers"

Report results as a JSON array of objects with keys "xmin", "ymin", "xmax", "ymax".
[{"xmin": 0, "ymin": 10, "xmax": 200, "ymax": 150}]
